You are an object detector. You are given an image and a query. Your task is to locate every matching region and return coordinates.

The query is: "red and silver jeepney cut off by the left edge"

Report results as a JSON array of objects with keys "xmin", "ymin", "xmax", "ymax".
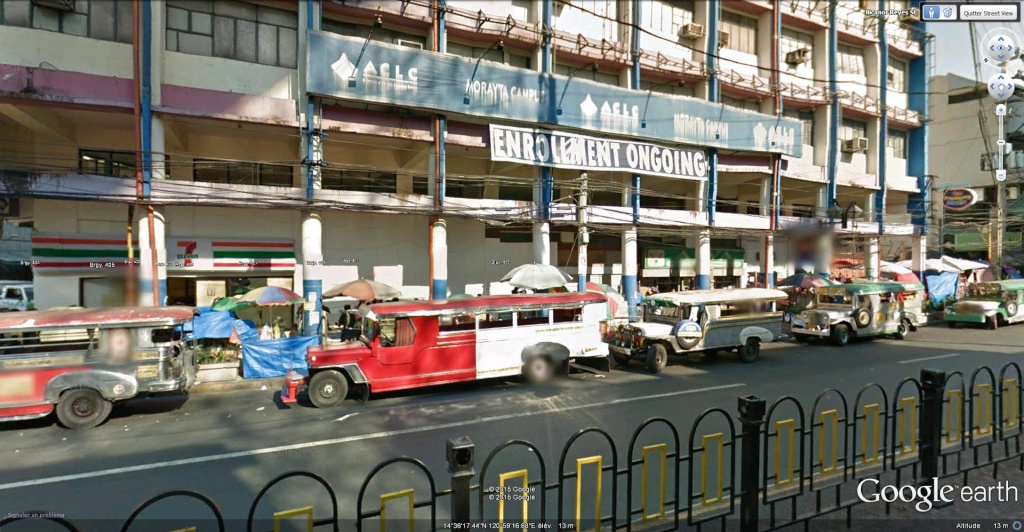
[{"xmin": 0, "ymin": 307, "xmax": 196, "ymax": 429}]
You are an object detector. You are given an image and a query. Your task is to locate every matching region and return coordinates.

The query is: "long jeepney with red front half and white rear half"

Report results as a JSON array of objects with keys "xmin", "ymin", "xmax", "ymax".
[{"xmin": 306, "ymin": 293, "xmax": 608, "ymax": 408}]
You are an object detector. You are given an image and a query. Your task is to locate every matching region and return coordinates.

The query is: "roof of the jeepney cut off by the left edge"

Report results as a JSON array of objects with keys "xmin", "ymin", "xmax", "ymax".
[{"xmin": 0, "ymin": 307, "xmax": 196, "ymax": 331}]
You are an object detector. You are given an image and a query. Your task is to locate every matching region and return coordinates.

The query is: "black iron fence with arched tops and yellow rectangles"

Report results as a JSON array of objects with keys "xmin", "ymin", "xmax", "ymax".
[{"xmin": 0, "ymin": 363, "xmax": 1024, "ymax": 532}]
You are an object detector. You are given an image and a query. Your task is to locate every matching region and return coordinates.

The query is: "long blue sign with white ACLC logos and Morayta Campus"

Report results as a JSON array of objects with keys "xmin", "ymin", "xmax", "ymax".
[{"xmin": 306, "ymin": 31, "xmax": 803, "ymax": 157}]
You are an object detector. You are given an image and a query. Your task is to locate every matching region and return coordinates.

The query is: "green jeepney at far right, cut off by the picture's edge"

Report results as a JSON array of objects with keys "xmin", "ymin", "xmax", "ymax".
[{"xmin": 943, "ymin": 279, "xmax": 1024, "ymax": 328}]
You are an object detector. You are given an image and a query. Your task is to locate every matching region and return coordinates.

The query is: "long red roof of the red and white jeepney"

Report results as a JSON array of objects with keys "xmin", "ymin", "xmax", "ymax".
[{"xmin": 370, "ymin": 292, "xmax": 608, "ymax": 315}]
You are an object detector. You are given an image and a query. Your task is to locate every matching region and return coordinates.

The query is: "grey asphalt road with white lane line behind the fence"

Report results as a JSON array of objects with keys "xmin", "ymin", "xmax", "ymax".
[{"xmin": 0, "ymin": 326, "xmax": 1024, "ymax": 532}]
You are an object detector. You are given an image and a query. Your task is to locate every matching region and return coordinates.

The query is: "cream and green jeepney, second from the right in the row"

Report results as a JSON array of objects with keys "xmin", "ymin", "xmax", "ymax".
[{"xmin": 792, "ymin": 282, "xmax": 921, "ymax": 346}]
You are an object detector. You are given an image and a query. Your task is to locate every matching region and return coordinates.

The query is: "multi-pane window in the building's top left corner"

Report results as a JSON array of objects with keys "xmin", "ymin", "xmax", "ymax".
[{"xmin": 0, "ymin": 0, "xmax": 131, "ymax": 44}]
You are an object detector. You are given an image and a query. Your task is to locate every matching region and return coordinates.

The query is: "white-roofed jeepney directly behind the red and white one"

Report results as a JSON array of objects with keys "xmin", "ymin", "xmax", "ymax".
[{"xmin": 609, "ymin": 289, "xmax": 788, "ymax": 373}]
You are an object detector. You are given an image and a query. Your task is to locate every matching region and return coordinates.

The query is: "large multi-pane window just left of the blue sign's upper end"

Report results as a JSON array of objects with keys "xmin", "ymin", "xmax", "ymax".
[{"xmin": 165, "ymin": 0, "xmax": 299, "ymax": 69}]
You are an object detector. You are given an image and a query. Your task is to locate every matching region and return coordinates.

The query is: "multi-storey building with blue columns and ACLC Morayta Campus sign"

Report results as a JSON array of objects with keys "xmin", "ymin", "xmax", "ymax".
[{"xmin": 0, "ymin": 0, "xmax": 930, "ymax": 319}]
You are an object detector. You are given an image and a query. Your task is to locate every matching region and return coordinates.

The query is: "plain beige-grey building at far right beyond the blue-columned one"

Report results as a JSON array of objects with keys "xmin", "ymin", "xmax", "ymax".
[{"xmin": 929, "ymin": 71, "xmax": 1024, "ymax": 265}]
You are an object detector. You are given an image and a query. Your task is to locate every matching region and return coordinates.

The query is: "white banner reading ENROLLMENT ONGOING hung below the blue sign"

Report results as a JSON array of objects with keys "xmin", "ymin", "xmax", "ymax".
[{"xmin": 490, "ymin": 124, "xmax": 708, "ymax": 179}]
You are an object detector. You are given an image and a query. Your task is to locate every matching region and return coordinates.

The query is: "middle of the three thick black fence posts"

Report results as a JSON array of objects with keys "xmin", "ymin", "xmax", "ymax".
[{"xmin": 737, "ymin": 395, "xmax": 765, "ymax": 532}]
